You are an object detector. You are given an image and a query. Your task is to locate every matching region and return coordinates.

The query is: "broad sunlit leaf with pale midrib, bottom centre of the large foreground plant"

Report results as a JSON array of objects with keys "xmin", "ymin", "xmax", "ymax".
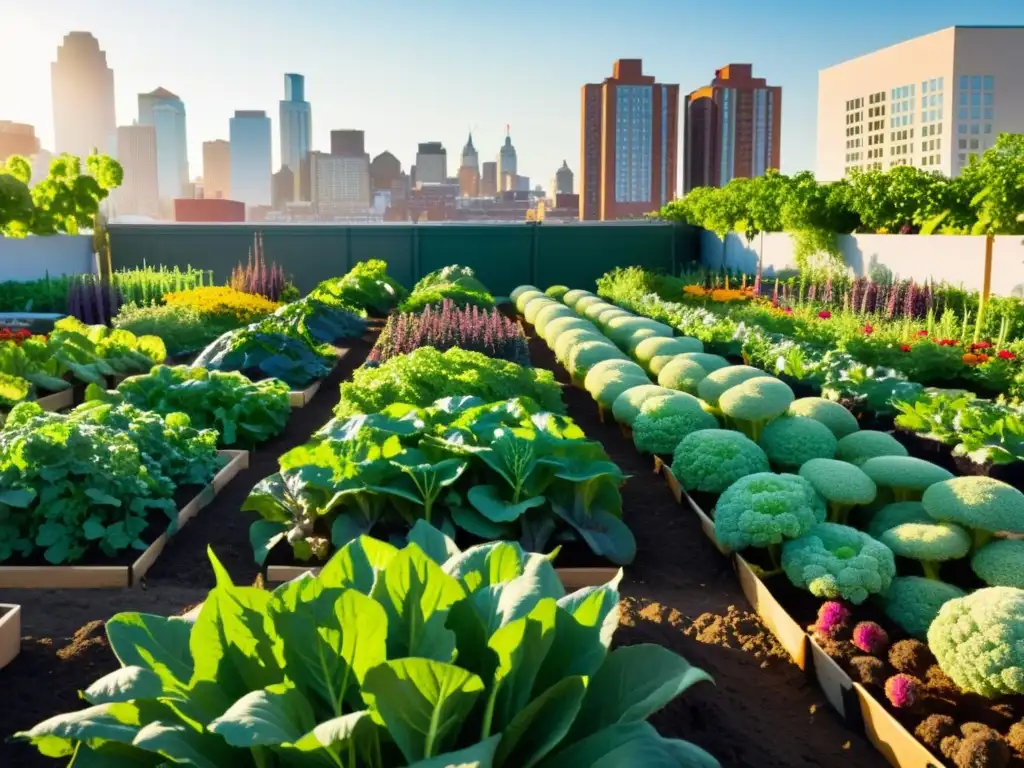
[{"xmin": 362, "ymin": 658, "xmax": 483, "ymax": 762}]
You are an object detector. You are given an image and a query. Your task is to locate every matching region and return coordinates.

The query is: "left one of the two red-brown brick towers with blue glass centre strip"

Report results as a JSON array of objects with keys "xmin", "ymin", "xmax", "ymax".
[{"xmin": 580, "ymin": 58, "xmax": 679, "ymax": 221}]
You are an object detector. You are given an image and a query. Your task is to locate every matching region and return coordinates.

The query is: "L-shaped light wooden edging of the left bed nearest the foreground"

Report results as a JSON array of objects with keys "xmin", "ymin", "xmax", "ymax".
[{"xmin": 0, "ymin": 451, "xmax": 249, "ymax": 589}]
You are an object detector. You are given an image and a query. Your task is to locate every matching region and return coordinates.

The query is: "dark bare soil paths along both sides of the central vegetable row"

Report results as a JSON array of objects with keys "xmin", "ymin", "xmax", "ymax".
[{"xmin": 0, "ymin": 331, "xmax": 885, "ymax": 768}]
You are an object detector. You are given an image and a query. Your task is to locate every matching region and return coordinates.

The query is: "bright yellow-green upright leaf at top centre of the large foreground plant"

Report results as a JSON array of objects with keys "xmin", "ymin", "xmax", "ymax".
[{"xmin": 372, "ymin": 544, "xmax": 466, "ymax": 662}]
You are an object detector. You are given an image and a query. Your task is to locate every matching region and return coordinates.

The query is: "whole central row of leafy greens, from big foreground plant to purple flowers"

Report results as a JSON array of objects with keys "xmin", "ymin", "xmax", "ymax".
[{"xmin": 8, "ymin": 267, "xmax": 718, "ymax": 768}]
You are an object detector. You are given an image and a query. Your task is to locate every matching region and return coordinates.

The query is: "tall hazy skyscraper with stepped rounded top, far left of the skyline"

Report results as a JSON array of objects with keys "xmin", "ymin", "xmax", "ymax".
[{"xmin": 50, "ymin": 32, "xmax": 117, "ymax": 159}]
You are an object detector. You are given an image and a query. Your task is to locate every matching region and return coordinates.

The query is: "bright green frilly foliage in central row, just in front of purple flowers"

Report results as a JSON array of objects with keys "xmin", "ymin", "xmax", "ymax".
[{"xmin": 335, "ymin": 347, "xmax": 565, "ymax": 418}]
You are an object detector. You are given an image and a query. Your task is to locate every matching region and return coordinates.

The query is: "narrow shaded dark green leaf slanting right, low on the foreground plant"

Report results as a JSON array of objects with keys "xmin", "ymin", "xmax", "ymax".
[{"xmin": 495, "ymin": 676, "xmax": 587, "ymax": 768}]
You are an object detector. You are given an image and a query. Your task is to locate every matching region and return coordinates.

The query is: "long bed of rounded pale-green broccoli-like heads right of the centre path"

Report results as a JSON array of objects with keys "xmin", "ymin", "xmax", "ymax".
[{"xmin": 513, "ymin": 286, "xmax": 1024, "ymax": 766}]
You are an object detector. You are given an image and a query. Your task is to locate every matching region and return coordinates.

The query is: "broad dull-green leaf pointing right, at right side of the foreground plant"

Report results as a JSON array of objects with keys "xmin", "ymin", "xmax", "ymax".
[{"xmin": 572, "ymin": 644, "xmax": 714, "ymax": 740}]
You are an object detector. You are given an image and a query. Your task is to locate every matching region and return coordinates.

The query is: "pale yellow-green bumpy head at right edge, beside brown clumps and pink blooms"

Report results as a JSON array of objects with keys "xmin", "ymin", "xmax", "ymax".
[{"xmin": 928, "ymin": 587, "xmax": 1024, "ymax": 698}]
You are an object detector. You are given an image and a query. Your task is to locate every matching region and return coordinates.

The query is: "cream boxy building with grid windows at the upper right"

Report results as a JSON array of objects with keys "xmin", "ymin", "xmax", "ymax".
[{"xmin": 816, "ymin": 27, "xmax": 1024, "ymax": 181}]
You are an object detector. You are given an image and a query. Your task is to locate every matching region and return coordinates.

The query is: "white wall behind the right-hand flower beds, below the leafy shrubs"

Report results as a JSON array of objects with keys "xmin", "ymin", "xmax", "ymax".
[{"xmin": 700, "ymin": 231, "xmax": 1024, "ymax": 296}]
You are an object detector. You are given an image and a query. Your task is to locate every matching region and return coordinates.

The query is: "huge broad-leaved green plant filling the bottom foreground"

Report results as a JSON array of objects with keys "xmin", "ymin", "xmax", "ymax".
[{"xmin": 15, "ymin": 524, "xmax": 718, "ymax": 768}]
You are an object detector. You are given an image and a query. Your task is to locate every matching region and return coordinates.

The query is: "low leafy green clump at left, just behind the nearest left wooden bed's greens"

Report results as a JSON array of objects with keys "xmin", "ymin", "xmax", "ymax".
[{"xmin": 86, "ymin": 366, "xmax": 291, "ymax": 447}]
